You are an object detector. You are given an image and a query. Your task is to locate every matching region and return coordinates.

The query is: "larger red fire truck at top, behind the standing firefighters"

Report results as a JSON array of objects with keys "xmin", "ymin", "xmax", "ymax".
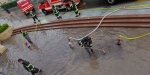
[{"xmin": 38, "ymin": 0, "xmax": 80, "ymax": 15}]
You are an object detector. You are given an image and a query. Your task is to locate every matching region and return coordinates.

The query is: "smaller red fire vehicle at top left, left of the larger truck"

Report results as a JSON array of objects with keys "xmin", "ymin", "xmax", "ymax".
[{"xmin": 17, "ymin": 0, "xmax": 35, "ymax": 15}]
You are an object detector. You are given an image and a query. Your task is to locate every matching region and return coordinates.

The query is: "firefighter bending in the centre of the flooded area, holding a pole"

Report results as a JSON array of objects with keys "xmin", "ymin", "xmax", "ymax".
[{"xmin": 79, "ymin": 36, "xmax": 93, "ymax": 55}]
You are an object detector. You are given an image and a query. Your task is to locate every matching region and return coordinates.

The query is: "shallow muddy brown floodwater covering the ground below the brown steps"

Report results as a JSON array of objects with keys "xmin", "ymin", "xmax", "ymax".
[{"xmin": 0, "ymin": 27, "xmax": 150, "ymax": 75}]
